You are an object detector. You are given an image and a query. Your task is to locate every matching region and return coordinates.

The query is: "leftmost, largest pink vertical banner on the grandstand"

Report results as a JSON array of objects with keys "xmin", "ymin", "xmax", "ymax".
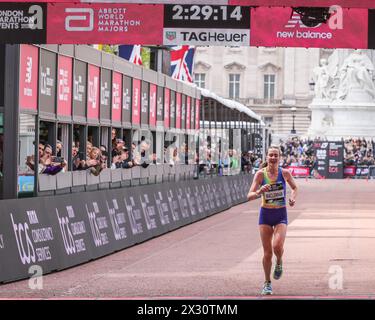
[{"xmin": 19, "ymin": 44, "xmax": 39, "ymax": 111}]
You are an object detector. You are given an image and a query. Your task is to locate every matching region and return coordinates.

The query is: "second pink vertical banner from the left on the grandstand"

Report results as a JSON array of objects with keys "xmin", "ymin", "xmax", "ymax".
[{"xmin": 57, "ymin": 55, "xmax": 73, "ymax": 116}]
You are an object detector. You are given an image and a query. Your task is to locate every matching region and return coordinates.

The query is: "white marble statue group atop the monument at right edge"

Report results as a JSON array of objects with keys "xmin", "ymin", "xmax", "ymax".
[{"xmin": 337, "ymin": 50, "xmax": 375, "ymax": 100}]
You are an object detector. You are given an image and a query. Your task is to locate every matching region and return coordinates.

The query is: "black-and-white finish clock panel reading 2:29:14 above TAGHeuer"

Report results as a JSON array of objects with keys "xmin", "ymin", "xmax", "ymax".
[{"xmin": 163, "ymin": 4, "xmax": 250, "ymax": 46}]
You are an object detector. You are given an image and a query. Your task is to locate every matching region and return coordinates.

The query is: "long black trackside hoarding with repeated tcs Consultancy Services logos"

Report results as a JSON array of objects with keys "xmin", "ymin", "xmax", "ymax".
[{"xmin": 0, "ymin": 175, "xmax": 252, "ymax": 282}]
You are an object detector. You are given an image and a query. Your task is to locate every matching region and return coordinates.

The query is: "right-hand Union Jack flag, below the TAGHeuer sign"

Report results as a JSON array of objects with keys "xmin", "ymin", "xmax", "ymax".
[{"xmin": 171, "ymin": 46, "xmax": 195, "ymax": 82}]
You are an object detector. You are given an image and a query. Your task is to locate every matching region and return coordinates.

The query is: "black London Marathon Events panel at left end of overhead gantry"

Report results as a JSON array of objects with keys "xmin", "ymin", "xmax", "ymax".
[{"xmin": 0, "ymin": 2, "xmax": 47, "ymax": 44}]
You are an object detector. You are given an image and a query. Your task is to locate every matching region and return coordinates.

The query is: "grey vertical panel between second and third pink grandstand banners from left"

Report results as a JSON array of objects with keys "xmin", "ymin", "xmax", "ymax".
[{"xmin": 73, "ymin": 60, "xmax": 87, "ymax": 117}]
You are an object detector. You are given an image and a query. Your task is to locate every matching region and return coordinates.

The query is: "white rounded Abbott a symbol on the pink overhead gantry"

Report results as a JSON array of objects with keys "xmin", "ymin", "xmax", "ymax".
[{"xmin": 65, "ymin": 8, "xmax": 94, "ymax": 31}]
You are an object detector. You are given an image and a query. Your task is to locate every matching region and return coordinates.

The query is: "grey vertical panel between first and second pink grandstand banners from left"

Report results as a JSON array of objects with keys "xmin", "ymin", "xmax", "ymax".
[{"xmin": 39, "ymin": 49, "xmax": 57, "ymax": 115}]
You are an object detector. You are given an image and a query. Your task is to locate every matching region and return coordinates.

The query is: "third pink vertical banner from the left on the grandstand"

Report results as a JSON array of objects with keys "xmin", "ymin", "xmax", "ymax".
[{"xmin": 87, "ymin": 64, "xmax": 99, "ymax": 120}]
